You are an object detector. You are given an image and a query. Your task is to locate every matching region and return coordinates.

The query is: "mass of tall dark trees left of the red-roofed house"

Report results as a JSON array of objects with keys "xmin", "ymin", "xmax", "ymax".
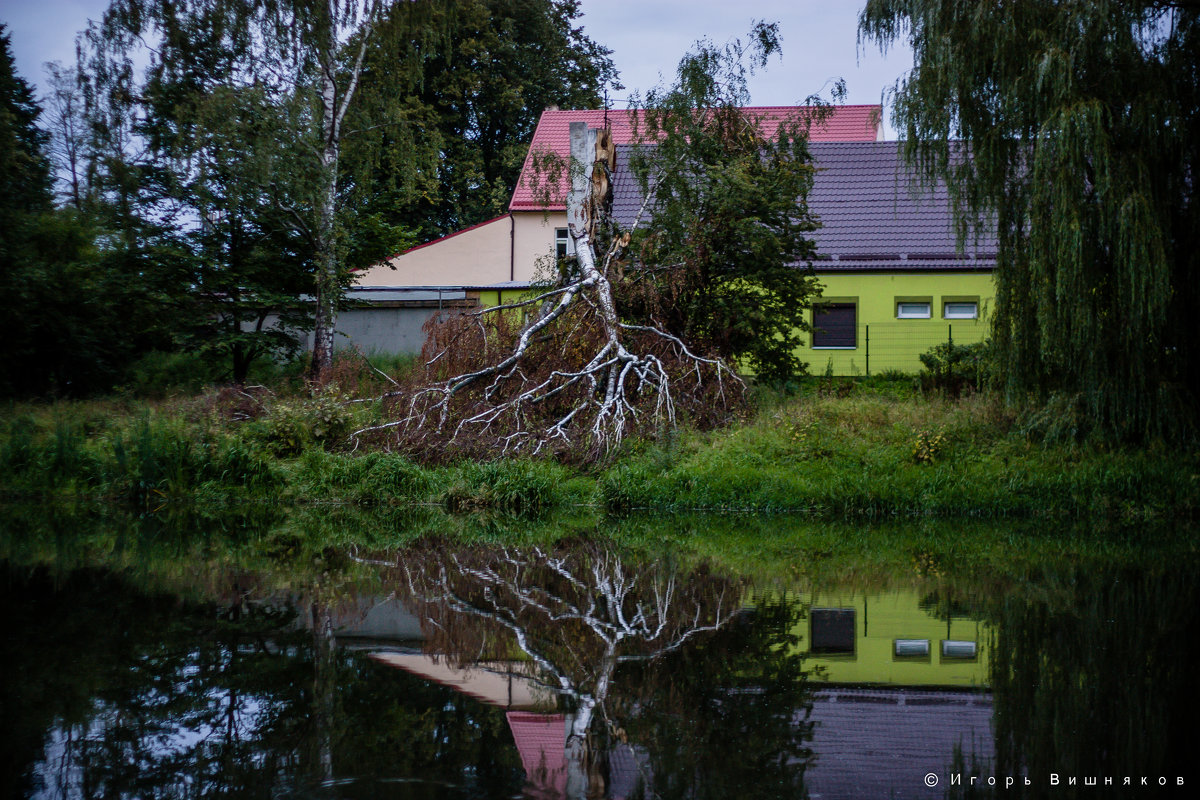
[{"xmin": 0, "ymin": 0, "xmax": 614, "ymax": 396}]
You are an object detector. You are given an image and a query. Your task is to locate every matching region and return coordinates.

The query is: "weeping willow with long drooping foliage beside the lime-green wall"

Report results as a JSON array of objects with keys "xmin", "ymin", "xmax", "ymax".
[{"xmin": 859, "ymin": 0, "xmax": 1200, "ymax": 441}]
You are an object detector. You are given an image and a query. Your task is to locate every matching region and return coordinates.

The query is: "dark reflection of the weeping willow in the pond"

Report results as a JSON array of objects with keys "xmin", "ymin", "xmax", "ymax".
[{"xmin": 955, "ymin": 563, "xmax": 1200, "ymax": 798}]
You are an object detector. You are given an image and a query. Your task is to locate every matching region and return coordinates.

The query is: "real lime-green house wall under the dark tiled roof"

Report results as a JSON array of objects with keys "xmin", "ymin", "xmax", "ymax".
[{"xmin": 800, "ymin": 272, "xmax": 996, "ymax": 375}]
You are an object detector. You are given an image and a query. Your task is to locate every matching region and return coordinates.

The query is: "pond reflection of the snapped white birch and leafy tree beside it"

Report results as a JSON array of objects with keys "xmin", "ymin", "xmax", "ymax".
[{"xmin": 406, "ymin": 545, "xmax": 810, "ymax": 798}]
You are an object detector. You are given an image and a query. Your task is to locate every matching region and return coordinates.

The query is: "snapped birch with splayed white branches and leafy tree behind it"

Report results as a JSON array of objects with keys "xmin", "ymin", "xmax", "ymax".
[{"xmin": 355, "ymin": 25, "xmax": 816, "ymax": 459}]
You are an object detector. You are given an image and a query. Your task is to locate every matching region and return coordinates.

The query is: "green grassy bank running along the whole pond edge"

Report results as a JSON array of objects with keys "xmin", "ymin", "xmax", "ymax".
[{"xmin": 0, "ymin": 380, "xmax": 1200, "ymax": 521}]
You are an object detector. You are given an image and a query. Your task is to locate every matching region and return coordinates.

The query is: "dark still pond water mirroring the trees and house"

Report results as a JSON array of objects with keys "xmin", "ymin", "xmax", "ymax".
[{"xmin": 0, "ymin": 509, "xmax": 1200, "ymax": 800}]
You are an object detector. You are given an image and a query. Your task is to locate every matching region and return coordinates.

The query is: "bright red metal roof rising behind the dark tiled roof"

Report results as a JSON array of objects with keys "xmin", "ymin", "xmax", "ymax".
[{"xmin": 509, "ymin": 106, "xmax": 881, "ymax": 211}]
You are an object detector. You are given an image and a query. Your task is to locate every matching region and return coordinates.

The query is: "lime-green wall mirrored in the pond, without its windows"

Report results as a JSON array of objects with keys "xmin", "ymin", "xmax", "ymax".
[{"xmin": 794, "ymin": 589, "xmax": 989, "ymax": 686}]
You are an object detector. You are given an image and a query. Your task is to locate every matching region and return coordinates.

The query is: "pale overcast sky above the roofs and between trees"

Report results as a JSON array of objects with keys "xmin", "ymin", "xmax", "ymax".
[{"xmin": 0, "ymin": 0, "xmax": 912, "ymax": 138}]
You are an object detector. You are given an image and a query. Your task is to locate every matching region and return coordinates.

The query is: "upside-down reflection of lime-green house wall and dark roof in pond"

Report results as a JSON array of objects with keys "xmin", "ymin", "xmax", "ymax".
[{"xmin": 797, "ymin": 590, "xmax": 995, "ymax": 800}]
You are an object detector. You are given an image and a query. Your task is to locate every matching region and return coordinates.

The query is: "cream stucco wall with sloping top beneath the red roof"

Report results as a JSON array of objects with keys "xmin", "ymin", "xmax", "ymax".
[{"xmin": 356, "ymin": 212, "xmax": 566, "ymax": 287}]
